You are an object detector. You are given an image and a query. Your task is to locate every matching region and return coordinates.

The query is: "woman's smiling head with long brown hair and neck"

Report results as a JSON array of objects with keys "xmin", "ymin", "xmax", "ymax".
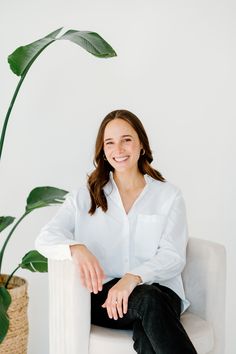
[{"xmin": 88, "ymin": 110, "xmax": 165, "ymax": 215}]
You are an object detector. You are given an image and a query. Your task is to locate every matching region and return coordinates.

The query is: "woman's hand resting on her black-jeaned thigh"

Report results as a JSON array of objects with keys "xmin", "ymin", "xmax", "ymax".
[{"xmin": 102, "ymin": 273, "xmax": 142, "ymax": 320}]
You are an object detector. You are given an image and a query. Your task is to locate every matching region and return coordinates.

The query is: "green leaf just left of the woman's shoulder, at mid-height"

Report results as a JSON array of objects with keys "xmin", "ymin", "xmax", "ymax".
[{"xmin": 25, "ymin": 187, "xmax": 68, "ymax": 212}]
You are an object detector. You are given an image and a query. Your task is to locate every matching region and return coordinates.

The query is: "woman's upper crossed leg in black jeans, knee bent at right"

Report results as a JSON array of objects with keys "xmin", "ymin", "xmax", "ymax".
[{"xmin": 129, "ymin": 283, "xmax": 197, "ymax": 354}]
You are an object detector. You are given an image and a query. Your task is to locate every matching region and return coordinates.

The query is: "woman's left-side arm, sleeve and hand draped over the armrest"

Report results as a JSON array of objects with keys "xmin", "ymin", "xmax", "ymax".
[{"xmin": 35, "ymin": 193, "xmax": 105, "ymax": 294}]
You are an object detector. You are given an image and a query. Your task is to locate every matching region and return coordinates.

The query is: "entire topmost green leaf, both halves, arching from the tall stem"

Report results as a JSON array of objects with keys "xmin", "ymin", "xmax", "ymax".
[{"xmin": 8, "ymin": 28, "xmax": 116, "ymax": 76}]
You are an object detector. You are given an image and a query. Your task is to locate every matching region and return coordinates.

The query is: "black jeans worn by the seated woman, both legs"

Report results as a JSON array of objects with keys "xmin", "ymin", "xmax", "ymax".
[{"xmin": 91, "ymin": 278, "xmax": 197, "ymax": 354}]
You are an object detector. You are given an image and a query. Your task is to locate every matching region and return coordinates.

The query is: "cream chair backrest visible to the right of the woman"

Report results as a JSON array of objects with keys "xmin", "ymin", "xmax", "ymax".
[{"xmin": 182, "ymin": 238, "xmax": 226, "ymax": 354}]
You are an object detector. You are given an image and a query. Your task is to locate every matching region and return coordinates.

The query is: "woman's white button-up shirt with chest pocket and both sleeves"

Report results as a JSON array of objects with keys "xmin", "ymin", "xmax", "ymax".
[{"xmin": 35, "ymin": 172, "xmax": 189, "ymax": 312}]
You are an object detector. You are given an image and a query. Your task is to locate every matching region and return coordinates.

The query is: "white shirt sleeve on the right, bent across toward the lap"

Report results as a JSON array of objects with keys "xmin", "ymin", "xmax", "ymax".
[{"xmin": 128, "ymin": 191, "xmax": 188, "ymax": 284}]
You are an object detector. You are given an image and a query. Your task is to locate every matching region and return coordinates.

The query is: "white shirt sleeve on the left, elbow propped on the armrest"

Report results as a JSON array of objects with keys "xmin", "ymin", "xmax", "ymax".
[{"xmin": 35, "ymin": 192, "xmax": 79, "ymax": 260}]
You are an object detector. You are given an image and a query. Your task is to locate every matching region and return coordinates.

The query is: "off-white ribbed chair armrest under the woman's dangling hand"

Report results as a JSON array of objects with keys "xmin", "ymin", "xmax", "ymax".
[{"xmin": 48, "ymin": 260, "xmax": 91, "ymax": 354}]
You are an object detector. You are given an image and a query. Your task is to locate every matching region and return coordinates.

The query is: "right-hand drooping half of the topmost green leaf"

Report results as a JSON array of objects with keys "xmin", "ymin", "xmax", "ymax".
[{"xmin": 58, "ymin": 30, "xmax": 116, "ymax": 58}]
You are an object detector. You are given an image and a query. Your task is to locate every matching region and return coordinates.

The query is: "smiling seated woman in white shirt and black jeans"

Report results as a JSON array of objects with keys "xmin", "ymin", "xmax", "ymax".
[{"xmin": 36, "ymin": 110, "xmax": 196, "ymax": 354}]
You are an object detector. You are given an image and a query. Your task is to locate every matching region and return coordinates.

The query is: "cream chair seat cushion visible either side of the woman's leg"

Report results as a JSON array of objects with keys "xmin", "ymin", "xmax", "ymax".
[{"xmin": 89, "ymin": 311, "xmax": 214, "ymax": 354}]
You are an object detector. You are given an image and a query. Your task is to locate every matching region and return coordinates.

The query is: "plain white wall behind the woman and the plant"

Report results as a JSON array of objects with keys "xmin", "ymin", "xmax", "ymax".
[{"xmin": 0, "ymin": 0, "xmax": 236, "ymax": 354}]
